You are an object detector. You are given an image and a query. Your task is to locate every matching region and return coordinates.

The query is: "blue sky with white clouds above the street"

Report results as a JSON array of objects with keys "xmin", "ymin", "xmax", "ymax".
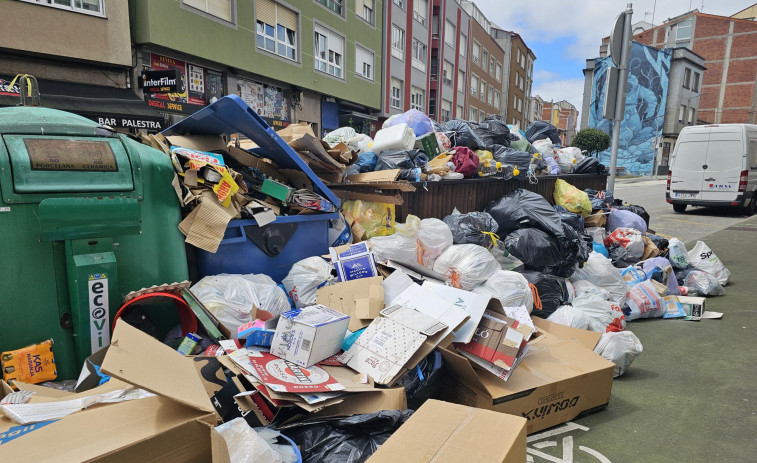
[{"xmin": 475, "ymin": 0, "xmax": 757, "ymax": 125}]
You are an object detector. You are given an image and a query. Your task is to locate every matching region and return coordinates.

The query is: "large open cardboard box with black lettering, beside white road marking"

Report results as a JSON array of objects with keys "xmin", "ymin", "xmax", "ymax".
[{"xmin": 441, "ymin": 319, "xmax": 615, "ymax": 434}]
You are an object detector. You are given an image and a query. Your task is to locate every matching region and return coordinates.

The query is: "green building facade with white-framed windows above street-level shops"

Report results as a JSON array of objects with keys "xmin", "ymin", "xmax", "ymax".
[{"xmin": 129, "ymin": 0, "xmax": 383, "ymax": 134}]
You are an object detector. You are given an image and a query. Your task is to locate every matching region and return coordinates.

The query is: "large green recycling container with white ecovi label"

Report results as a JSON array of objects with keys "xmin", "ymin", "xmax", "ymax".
[{"xmin": 0, "ymin": 107, "xmax": 188, "ymax": 379}]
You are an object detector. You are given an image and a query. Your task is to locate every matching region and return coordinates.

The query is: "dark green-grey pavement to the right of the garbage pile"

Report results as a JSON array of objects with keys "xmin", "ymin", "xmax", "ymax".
[{"xmin": 568, "ymin": 217, "xmax": 757, "ymax": 463}]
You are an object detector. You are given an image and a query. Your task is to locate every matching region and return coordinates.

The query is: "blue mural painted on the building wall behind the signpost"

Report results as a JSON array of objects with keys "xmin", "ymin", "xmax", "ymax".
[{"xmin": 589, "ymin": 42, "xmax": 670, "ymax": 175}]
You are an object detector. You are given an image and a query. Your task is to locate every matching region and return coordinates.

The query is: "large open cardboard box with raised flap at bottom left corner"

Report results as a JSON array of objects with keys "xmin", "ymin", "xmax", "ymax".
[{"xmin": 0, "ymin": 320, "xmax": 217, "ymax": 463}]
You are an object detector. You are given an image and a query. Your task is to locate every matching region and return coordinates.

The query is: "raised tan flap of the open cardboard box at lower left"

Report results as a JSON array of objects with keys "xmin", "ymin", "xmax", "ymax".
[{"xmin": 102, "ymin": 320, "xmax": 215, "ymax": 413}]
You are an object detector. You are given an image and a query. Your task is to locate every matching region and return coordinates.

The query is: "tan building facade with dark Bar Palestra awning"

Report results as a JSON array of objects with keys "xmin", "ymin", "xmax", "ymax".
[{"xmin": 0, "ymin": 0, "xmax": 165, "ymax": 131}]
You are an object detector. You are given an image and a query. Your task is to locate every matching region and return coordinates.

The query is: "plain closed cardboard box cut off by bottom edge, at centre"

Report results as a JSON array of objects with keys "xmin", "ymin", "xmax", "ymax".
[{"xmin": 368, "ymin": 400, "xmax": 526, "ymax": 463}]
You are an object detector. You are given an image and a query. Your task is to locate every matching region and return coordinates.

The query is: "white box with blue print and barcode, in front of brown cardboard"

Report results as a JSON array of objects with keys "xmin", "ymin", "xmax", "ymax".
[{"xmin": 271, "ymin": 304, "xmax": 350, "ymax": 368}]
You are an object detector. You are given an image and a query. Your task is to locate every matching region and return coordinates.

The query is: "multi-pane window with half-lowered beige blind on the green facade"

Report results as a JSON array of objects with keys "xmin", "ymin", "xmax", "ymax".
[{"xmin": 255, "ymin": 0, "xmax": 297, "ymax": 61}]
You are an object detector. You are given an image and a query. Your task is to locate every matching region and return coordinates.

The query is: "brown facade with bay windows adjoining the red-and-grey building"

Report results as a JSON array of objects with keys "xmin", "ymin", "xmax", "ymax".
[{"xmin": 461, "ymin": 1, "xmax": 505, "ymax": 122}]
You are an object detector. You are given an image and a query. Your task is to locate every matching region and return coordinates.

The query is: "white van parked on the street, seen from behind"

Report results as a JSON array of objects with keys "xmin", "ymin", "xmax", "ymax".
[{"xmin": 665, "ymin": 124, "xmax": 757, "ymax": 214}]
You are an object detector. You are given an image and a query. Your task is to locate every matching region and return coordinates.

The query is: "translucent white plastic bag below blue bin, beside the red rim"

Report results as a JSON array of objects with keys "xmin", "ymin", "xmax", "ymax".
[{"xmin": 191, "ymin": 273, "xmax": 290, "ymax": 337}]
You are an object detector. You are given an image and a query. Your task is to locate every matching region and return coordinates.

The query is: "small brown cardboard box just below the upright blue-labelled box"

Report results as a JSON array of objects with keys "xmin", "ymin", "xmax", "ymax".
[{"xmin": 316, "ymin": 277, "xmax": 384, "ymax": 331}]
